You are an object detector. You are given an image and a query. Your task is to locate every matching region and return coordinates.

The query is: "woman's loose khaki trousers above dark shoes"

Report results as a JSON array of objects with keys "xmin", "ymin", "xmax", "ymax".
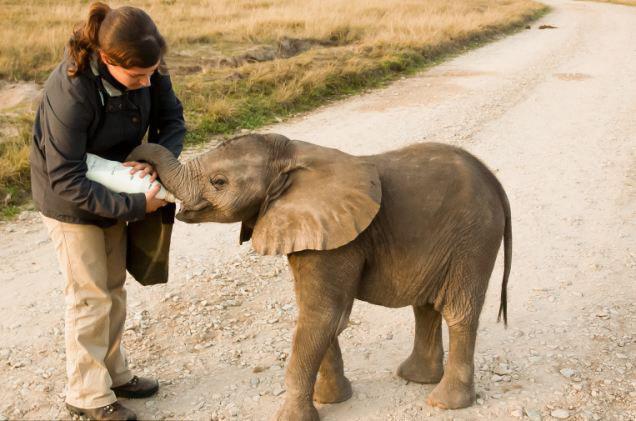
[{"xmin": 42, "ymin": 216, "xmax": 132, "ymax": 409}]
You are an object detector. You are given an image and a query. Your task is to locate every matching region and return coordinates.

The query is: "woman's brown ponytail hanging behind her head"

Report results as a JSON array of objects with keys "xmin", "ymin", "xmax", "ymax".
[{"xmin": 67, "ymin": 2, "xmax": 111, "ymax": 77}]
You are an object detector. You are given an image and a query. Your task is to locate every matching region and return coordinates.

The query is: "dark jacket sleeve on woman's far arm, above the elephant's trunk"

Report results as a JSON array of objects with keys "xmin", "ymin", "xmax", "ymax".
[{"xmin": 148, "ymin": 73, "xmax": 186, "ymax": 157}]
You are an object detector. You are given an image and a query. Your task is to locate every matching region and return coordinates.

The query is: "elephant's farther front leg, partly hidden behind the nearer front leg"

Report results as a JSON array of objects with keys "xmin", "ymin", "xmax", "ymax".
[{"xmin": 314, "ymin": 300, "xmax": 353, "ymax": 403}]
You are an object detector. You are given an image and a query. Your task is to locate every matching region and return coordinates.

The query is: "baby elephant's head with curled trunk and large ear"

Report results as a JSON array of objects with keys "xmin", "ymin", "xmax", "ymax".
[{"xmin": 128, "ymin": 134, "xmax": 382, "ymax": 254}]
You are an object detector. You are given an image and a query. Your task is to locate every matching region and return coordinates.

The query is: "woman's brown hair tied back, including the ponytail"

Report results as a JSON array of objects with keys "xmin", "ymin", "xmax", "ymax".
[{"xmin": 67, "ymin": 2, "xmax": 167, "ymax": 77}]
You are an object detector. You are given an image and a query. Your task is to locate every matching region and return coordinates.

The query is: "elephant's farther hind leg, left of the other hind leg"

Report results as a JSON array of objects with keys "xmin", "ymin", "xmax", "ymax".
[{"xmin": 397, "ymin": 304, "xmax": 444, "ymax": 384}]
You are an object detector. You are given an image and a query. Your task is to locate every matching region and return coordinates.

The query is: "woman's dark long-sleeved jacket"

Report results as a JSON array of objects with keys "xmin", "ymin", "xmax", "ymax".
[{"xmin": 30, "ymin": 58, "xmax": 185, "ymax": 227}]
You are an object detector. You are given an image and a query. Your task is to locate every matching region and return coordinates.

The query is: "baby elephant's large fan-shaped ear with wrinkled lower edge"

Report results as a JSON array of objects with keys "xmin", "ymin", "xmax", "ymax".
[{"xmin": 252, "ymin": 141, "xmax": 382, "ymax": 254}]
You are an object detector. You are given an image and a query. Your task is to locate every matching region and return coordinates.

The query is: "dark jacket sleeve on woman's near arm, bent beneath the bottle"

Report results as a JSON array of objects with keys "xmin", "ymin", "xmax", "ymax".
[{"xmin": 41, "ymin": 80, "xmax": 146, "ymax": 221}]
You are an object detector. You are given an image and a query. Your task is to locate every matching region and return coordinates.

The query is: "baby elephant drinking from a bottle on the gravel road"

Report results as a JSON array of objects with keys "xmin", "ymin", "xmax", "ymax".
[{"xmin": 128, "ymin": 134, "xmax": 512, "ymax": 421}]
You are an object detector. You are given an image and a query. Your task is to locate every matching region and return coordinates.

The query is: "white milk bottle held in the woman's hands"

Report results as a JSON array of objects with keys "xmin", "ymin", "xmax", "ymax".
[{"xmin": 86, "ymin": 153, "xmax": 175, "ymax": 203}]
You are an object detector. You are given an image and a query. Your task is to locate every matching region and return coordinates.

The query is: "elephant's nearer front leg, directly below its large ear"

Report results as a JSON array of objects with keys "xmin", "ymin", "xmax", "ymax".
[{"xmin": 275, "ymin": 250, "xmax": 363, "ymax": 421}]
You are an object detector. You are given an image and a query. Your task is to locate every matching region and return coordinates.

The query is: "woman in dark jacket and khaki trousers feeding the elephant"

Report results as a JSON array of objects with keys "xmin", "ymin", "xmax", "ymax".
[{"xmin": 31, "ymin": 3, "xmax": 185, "ymax": 419}]
